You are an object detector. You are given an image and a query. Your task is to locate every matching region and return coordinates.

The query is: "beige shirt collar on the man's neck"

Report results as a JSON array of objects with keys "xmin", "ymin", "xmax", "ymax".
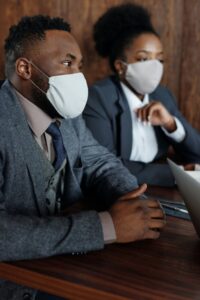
[{"xmin": 14, "ymin": 89, "xmax": 55, "ymax": 137}]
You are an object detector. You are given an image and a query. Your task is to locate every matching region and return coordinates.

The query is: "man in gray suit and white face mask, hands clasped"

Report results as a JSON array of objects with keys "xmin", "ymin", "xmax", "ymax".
[{"xmin": 0, "ymin": 16, "xmax": 165, "ymax": 300}]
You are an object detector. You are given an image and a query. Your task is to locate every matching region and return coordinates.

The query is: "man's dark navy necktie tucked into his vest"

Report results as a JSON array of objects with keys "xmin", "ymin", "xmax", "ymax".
[{"xmin": 46, "ymin": 122, "xmax": 66, "ymax": 171}]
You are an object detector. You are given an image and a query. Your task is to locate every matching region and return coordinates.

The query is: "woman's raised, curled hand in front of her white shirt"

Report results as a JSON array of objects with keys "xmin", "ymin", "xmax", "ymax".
[{"xmin": 136, "ymin": 101, "xmax": 177, "ymax": 132}]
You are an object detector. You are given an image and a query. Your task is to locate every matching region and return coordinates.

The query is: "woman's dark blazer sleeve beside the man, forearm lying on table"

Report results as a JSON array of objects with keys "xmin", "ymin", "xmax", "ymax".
[{"xmin": 84, "ymin": 86, "xmax": 174, "ymax": 186}]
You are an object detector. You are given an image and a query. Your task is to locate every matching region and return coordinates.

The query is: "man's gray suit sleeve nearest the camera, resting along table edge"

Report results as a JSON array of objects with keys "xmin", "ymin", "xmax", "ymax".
[{"xmin": 0, "ymin": 146, "xmax": 104, "ymax": 261}]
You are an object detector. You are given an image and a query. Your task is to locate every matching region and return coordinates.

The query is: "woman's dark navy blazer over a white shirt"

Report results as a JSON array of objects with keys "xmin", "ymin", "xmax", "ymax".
[{"xmin": 84, "ymin": 76, "xmax": 200, "ymax": 186}]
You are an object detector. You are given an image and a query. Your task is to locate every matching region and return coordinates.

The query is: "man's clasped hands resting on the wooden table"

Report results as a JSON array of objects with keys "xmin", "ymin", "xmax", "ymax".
[{"xmin": 109, "ymin": 184, "xmax": 166, "ymax": 243}]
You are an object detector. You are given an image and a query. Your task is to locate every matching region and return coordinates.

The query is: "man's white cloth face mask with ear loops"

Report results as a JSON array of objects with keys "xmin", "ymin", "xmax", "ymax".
[{"xmin": 30, "ymin": 62, "xmax": 88, "ymax": 119}]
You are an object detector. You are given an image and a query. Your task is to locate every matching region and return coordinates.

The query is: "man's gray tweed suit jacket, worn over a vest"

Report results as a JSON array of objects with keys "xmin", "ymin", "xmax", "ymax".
[{"xmin": 0, "ymin": 81, "xmax": 137, "ymax": 300}]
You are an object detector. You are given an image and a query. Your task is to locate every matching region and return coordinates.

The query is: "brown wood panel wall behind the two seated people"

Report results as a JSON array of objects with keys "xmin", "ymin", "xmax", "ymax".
[{"xmin": 0, "ymin": 0, "xmax": 200, "ymax": 129}]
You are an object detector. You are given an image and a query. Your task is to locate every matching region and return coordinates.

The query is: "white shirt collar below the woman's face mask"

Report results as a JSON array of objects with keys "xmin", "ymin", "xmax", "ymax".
[{"xmin": 120, "ymin": 81, "xmax": 149, "ymax": 109}]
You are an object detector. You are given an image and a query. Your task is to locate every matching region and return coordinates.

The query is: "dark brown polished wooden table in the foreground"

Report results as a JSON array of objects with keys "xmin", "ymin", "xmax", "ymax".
[{"xmin": 0, "ymin": 189, "xmax": 200, "ymax": 300}]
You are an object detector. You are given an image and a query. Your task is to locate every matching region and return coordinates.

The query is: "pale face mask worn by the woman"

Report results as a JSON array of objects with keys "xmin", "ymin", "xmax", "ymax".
[{"xmin": 125, "ymin": 59, "xmax": 163, "ymax": 95}]
